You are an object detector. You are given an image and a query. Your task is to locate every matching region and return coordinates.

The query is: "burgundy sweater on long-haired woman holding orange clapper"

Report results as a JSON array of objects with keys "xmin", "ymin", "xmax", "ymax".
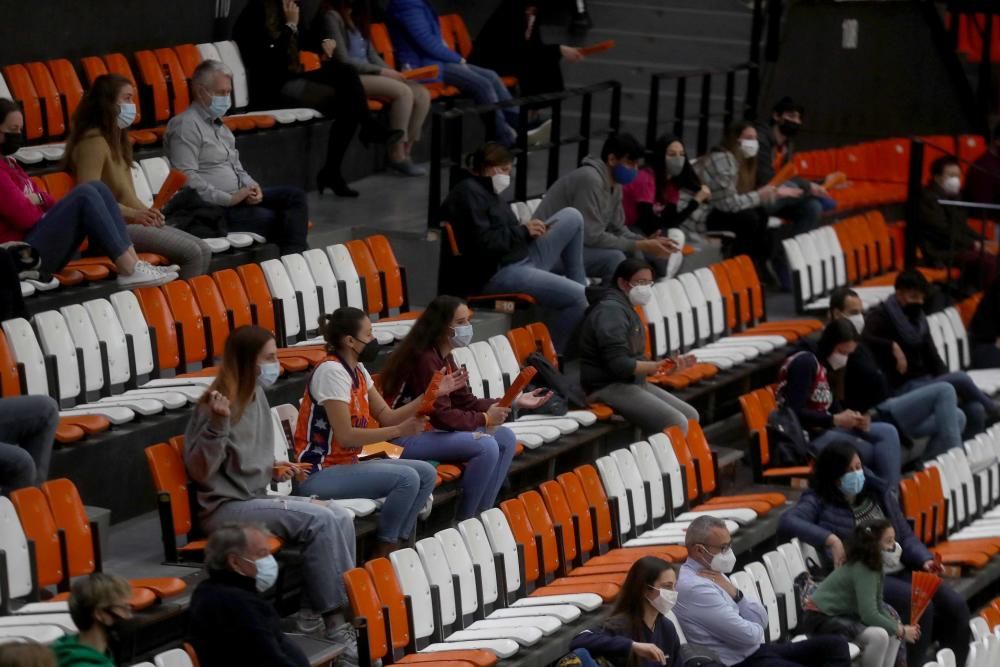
[{"xmin": 392, "ymin": 348, "xmax": 496, "ymax": 431}]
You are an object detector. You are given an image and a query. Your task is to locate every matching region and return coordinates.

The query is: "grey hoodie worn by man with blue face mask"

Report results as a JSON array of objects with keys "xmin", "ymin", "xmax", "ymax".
[{"xmin": 535, "ymin": 155, "xmax": 644, "ymax": 254}]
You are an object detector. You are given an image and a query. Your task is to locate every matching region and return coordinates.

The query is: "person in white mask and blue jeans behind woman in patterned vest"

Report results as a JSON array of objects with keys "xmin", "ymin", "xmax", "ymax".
[{"xmin": 830, "ymin": 287, "xmax": 965, "ymax": 460}]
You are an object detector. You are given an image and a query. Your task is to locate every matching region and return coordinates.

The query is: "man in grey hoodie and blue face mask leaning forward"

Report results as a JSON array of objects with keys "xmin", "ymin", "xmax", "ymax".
[{"xmin": 535, "ymin": 134, "xmax": 680, "ymax": 285}]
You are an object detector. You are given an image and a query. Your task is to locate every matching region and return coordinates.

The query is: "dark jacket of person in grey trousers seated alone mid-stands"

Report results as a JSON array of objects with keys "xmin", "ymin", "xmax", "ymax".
[{"xmin": 578, "ymin": 288, "xmax": 646, "ymax": 393}]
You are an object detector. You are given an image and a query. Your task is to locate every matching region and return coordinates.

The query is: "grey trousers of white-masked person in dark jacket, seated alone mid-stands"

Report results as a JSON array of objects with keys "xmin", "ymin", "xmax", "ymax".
[{"xmin": 588, "ymin": 381, "xmax": 698, "ymax": 435}]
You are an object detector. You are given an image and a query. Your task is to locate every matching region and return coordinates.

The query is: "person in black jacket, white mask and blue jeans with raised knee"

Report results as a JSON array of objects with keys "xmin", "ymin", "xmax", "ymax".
[{"xmin": 441, "ymin": 142, "xmax": 587, "ymax": 351}]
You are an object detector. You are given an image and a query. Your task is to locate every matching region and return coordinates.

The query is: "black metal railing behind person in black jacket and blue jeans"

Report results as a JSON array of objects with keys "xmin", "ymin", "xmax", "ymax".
[{"xmin": 427, "ymin": 81, "xmax": 622, "ymax": 228}]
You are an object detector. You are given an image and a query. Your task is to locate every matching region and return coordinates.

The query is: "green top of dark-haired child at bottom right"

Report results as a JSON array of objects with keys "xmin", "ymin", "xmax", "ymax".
[{"xmin": 812, "ymin": 563, "xmax": 899, "ymax": 637}]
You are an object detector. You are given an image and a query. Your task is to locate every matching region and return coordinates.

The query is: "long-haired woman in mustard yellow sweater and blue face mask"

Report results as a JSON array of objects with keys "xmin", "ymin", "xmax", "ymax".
[{"xmin": 66, "ymin": 74, "xmax": 212, "ymax": 278}]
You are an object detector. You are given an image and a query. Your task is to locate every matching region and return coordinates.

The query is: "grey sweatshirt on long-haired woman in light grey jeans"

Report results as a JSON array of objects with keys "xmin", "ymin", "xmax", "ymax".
[{"xmin": 184, "ymin": 386, "xmax": 274, "ymax": 518}]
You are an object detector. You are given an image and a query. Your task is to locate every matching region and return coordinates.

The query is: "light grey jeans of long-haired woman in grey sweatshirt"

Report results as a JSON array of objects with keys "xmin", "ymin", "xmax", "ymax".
[{"xmin": 202, "ymin": 496, "xmax": 355, "ymax": 614}]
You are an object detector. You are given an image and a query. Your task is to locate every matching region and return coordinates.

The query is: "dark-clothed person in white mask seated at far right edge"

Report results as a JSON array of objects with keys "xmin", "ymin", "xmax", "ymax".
[{"xmin": 918, "ymin": 155, "xmax": 997, "ymax": 294}]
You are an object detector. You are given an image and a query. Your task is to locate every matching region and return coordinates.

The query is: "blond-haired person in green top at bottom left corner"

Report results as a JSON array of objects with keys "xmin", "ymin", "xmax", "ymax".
[{"xmin": 52, "ymin": 572, "xmax": 132, "ymax": 667}]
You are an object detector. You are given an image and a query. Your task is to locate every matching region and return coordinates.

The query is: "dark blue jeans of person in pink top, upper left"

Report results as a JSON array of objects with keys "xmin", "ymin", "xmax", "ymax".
[{"xmin": 24, "ymin": 181, "xmax": 132, "ymax": 273}]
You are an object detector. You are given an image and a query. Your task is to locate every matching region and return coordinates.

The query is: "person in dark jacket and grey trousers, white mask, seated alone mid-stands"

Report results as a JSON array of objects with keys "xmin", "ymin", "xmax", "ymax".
[{"xmin": 578, "ymin": 258, "xmax": 698, "ymax": 434}]
